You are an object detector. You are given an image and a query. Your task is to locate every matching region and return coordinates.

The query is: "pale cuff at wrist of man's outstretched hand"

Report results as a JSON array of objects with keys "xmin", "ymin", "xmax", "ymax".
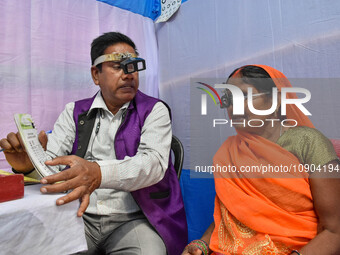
[{"xmin": 96, "ymin": 160, "xmax": 123, "ymax": 190}]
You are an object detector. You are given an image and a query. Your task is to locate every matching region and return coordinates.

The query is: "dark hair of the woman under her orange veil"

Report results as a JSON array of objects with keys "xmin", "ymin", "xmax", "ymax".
[{"xmin": 227, "ymin": 65, "xmax": 276, "ymax": 93}]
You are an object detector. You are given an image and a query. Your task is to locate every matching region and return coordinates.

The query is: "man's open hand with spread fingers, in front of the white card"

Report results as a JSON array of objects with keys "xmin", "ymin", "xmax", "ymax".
[{"xmin": 40, "ymin": 156, "xmax": 102, "ymax": 217}]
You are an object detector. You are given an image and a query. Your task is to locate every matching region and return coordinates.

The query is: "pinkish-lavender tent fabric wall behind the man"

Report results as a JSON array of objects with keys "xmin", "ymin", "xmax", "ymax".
[{"xmin": 0, "ymin": 0, "xmax": 158, "ymax": 169}]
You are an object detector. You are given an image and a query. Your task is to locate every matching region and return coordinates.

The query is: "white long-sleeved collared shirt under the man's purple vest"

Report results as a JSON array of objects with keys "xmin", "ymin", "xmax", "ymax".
[{"xmin": 41, "ymin": 92, "xmax": 172, "ymax": 215}]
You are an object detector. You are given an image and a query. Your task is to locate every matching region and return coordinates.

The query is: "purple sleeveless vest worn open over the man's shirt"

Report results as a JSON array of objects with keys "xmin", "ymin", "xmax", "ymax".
[{"xmin": 71, "ymin": 91, "xmax": 188, "ymax": 255}]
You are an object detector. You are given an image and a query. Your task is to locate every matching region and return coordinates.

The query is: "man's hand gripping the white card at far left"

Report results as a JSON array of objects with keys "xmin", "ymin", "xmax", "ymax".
[{"xmin": 0, "ymin": 131, "xmax": 47, "ymax": 173}]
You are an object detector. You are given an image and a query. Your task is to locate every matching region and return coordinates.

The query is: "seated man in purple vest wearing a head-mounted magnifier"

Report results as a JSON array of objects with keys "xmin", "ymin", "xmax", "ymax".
[{"xmin": 1, "ymin": 32, "xmax": 187, "ymax": 255}]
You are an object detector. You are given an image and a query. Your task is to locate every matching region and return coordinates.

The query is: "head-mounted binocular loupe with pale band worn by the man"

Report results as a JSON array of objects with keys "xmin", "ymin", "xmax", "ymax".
[{"xmin": 93, "ymin": 52, "xmax": 146, "ymax": 74}]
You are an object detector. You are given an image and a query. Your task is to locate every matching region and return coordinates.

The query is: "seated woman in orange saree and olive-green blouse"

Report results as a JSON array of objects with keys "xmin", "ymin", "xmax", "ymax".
[{"xmin": 182, "ymin": 65, "xmax": 340, "ymax": 255}]
